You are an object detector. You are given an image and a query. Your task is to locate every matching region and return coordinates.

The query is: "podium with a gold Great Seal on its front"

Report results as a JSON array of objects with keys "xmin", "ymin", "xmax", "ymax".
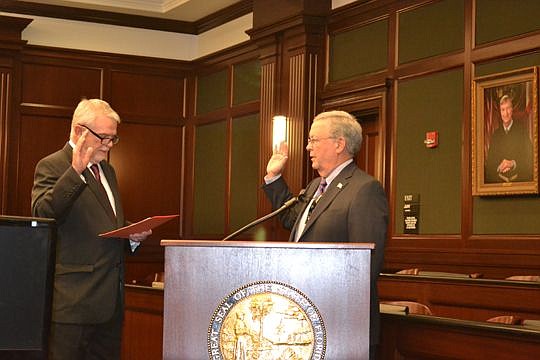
[{"xmin": 161, "ymin": 240, "xmax": 374, "ymax": 360}]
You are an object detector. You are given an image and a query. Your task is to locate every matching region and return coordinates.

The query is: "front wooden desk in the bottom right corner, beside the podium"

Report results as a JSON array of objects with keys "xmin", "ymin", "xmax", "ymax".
[{"xmin": 379, "ymin": 313, "xmax": 540, "ymax": 360}]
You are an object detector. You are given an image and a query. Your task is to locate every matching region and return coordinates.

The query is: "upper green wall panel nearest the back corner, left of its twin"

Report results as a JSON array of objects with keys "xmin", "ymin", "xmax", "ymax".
[{"xmin": 197, "ymin": 70, "xmax": 227, "ymax": 114}]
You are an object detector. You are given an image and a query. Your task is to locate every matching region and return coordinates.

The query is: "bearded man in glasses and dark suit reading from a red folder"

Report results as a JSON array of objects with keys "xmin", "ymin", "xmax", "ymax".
[{"xmin": 32, "ymin": 99, "xmax": 151, "ymax": 360}]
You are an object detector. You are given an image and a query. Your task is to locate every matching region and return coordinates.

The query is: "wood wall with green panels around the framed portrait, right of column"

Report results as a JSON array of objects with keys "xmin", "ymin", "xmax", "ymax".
[{"xmin": 319, "ymin": 0, "xmax": 540, "ymax": 278}]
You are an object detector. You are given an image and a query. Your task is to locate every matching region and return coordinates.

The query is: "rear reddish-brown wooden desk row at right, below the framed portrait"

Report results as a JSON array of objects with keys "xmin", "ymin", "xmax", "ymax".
[{"xmin": 378, "ymin": 274, "xmax": 540, "ymax": 321}]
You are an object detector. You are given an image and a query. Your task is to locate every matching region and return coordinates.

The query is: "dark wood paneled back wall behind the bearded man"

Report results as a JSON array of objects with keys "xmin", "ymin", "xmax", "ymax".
[{"xmin": 0, "ymin": 21, "xmax": 191, "ymax": 281}]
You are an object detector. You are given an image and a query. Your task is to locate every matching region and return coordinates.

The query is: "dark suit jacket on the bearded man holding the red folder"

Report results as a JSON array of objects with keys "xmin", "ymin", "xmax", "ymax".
[{"xmin": 32, "ymin": 144, "xmax": 127, "ymax": 324}]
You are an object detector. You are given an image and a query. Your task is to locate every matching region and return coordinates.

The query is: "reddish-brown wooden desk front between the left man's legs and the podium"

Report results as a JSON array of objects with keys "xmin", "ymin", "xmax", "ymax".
[{"xmin": 122, "ymin": 285, "xmax": 163, "ymax": 360}]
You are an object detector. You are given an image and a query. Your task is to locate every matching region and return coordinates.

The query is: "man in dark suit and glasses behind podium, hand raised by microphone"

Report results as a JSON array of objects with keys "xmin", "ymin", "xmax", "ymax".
[{"xmin": 263, "ymin": 111, "xmax": 388, "ymax": 358}]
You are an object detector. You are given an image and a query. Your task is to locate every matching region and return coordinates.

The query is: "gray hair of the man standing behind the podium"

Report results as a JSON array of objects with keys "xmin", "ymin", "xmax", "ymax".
[{"xmin": 313, "ymin": 110, "xmax": 362, "ymax": 157}]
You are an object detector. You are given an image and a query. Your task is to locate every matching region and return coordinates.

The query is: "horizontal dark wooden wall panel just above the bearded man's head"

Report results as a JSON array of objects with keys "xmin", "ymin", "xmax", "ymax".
[{"xmin": 22, "ymin": 63, "xmax": 103, "ymax": 108}]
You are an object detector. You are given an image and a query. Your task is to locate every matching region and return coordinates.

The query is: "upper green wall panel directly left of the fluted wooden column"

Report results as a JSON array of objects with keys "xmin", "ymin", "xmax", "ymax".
[{"xmin": 233, "ymin": 61, "xmax": 261, "ymax": 105}]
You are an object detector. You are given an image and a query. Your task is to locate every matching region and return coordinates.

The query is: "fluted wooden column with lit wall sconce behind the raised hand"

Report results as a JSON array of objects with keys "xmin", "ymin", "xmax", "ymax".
[{"xmin": 249, "ymin": 0, "xmax": 331, "ymax": 240}]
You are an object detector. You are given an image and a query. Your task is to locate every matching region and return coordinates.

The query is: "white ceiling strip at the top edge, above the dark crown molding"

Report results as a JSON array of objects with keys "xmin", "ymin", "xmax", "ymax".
[{"xmin": 19, "ymin": 0, "xmax": 240, "ymax": 22}]
